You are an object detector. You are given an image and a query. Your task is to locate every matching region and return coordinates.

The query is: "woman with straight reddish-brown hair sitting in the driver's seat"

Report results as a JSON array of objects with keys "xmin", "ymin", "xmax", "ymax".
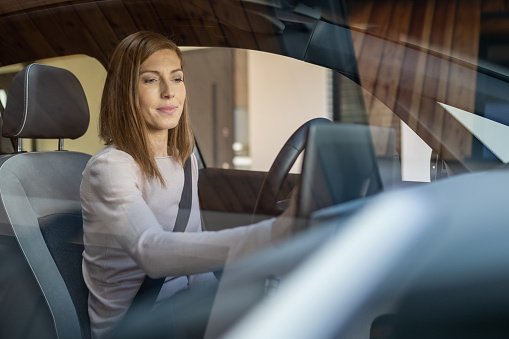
[{"xmin": 81, "ymin": 32, "xmax": 289, "ymax": 338}]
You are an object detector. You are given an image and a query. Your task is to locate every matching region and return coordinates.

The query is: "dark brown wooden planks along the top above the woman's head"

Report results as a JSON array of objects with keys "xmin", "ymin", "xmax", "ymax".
[{"xmin": 0, "ymin": 0, "xmax": 284, "ymax": 65}]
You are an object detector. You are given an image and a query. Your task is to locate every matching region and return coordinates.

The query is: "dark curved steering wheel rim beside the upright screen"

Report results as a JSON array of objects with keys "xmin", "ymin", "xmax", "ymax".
[{"xmin": 253, "ymin": 118, "xmax": 331, "ymax": 221}]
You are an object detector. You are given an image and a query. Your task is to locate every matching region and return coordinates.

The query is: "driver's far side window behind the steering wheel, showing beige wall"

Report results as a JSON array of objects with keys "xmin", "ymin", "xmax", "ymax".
[{"xmin": 184, "ymin": 48, "xmax": 431, "ymax": 185}]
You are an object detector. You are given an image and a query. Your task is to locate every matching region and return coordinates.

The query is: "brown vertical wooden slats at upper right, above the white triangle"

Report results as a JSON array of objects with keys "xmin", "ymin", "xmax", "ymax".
[{"xmin": 349, "ymin": 0, "xmax": 509, "ymax": 169}]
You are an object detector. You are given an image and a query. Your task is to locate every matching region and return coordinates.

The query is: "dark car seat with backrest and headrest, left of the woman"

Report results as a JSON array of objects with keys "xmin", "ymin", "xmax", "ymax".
[{"xmin": 0, "ymin": 64, "xmax": 90, "ymax": 338}]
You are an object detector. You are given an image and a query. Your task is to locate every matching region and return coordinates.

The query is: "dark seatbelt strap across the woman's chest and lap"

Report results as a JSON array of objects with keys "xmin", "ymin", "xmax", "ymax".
[{"xmin": 127, "ymin": 158, "xmax": 193, "ymax": 313}]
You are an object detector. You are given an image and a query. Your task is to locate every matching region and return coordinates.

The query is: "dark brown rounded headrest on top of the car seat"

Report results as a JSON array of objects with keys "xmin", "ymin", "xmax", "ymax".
[{"xmin": 2, "ymin": 64, "xmax": 90, "ymax": 139}]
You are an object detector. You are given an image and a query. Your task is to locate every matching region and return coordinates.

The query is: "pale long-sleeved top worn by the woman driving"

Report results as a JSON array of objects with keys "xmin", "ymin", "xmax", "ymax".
[{"xmin": 81, "ymin": 146, "xmax": 272, "ymax": 337}]
